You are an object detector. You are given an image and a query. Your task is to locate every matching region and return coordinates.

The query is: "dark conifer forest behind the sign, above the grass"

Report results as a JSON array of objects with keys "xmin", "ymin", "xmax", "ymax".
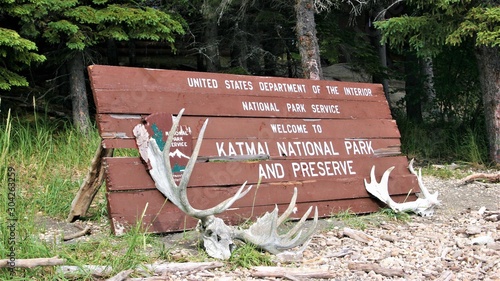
[{"xmin": 0, "ymin": 0, "xmax": 500, "ymax": 163}]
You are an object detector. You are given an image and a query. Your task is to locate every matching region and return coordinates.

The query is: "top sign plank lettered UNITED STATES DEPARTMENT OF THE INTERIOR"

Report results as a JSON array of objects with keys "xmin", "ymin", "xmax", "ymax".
[{"xmin": 88, "ymin": 65, "xmax": 385, "ymax": 100}]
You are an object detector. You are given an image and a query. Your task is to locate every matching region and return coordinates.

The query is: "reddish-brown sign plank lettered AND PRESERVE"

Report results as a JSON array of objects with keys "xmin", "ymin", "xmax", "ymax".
[{"xmin": 104, "ymin": 156, "xmax": 410, "ymax": 189}]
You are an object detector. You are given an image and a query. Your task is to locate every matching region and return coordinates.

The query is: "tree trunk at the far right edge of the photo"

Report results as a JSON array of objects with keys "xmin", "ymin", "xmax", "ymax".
[{"xmin": 477, "ymin": 46, "xmax": 500, "ymax": 164}]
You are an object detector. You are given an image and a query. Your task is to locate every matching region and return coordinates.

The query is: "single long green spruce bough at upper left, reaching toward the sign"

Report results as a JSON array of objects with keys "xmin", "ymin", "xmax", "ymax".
[{"xmin": 14, "ymin": 0, "xmax": 184, "ymax": 50}]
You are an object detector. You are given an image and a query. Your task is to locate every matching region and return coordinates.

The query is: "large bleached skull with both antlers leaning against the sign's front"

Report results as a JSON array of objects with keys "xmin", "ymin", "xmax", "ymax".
[{"xmin": 134, "ymin": 109, "xmax": 318, "ymax": 259}]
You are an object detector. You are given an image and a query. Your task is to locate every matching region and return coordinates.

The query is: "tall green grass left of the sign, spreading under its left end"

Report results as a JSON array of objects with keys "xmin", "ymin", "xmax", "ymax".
[{"xmin": 0, "ymin": 110, "xmax": 173, "ymax": 280}]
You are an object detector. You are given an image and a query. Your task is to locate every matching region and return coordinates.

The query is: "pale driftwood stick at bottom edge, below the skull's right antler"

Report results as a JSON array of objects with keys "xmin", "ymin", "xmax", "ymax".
[{"xmin": 251, "ymin": 266, "xmax": 335, "ymax": 280}]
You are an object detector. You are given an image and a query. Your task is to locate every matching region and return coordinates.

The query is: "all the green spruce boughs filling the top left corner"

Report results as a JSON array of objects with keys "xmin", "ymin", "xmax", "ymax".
[{"xmin": 0, "ymin": 0, "xmax": 184, "ymax": 90}]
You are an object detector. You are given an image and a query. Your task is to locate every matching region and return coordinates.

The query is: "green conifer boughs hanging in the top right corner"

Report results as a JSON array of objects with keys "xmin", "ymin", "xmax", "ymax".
[{"xmin": 375, "ymin": 0, "xmax": 500, "ymax": 57}]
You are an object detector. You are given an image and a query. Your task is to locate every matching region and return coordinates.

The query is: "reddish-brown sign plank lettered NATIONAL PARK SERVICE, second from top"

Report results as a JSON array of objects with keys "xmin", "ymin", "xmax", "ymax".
[{"xmin": 95, "ymin": 90, "xmax": 391, "ymax": 119}]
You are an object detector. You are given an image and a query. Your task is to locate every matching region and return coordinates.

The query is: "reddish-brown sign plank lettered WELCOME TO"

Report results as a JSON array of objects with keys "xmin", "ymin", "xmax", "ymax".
[{"xmin": 98, "ymin": 115, "xmax": 400, "ymax": 139}]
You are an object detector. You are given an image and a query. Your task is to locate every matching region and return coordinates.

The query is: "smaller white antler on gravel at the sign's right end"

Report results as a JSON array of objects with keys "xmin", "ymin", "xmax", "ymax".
[{"xmin": 365, "ymin": 159, "xmax": 440, "ymax": 217}]
